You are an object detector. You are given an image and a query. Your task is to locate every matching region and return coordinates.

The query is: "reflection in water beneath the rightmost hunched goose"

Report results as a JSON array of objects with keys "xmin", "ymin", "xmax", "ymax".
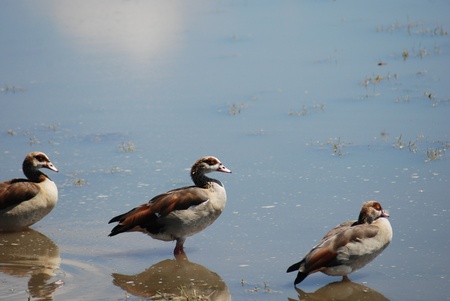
[{"xmin": 288, "ymin": 281, "xmax": 389, "ymax": 301}]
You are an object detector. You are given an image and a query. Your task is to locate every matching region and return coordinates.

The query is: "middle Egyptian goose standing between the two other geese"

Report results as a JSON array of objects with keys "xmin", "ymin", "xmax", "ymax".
[{"xmin": 109, "ymin": 157, "xmax": 231, "ymax": 255}]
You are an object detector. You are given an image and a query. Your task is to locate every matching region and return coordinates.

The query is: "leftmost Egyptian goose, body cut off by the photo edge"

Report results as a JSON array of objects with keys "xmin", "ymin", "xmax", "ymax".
[{"xmin": 0, "ymin": 152, "xmax": 58, "ymax": 231}]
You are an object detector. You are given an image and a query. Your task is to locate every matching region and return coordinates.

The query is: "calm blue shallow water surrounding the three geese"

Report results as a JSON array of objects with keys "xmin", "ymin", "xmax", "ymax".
[{"xmin": 0, "ymin": 1, "xmax": 450, "ymax": 300}]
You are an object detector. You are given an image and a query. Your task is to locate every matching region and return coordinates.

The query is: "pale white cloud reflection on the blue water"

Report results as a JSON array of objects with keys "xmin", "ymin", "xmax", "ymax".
[{"xmin": 50, "ymin": 1, "xmax": 184, "ymax": 61}]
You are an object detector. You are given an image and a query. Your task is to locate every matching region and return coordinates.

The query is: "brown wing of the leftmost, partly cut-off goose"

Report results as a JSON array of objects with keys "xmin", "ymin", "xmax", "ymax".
[{"xmin": 0, "ymin": 179, "xmax": 40, "ymax": 210}]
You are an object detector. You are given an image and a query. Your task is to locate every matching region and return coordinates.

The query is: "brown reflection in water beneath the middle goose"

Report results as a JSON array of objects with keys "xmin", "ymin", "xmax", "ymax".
[{"xmin": 112, "ymin": 254, "xmax": 231, "ymax": 301}]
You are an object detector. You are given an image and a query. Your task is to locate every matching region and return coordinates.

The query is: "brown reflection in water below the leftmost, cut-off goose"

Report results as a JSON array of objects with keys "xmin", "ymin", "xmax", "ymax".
[{"xmin": 0, "ymin": 229, "xmax": 63, "ymax": 300}]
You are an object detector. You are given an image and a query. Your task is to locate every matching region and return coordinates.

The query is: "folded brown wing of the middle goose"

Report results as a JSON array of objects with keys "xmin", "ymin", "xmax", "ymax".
[{"xmin": 109, "ymin": 186, "xmax": 208, "ymax": 236}]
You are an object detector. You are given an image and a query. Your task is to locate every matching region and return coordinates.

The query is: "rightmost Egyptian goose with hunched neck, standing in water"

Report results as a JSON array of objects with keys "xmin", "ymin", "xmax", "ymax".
[{"xmin": 287, "ymin": 201, "xmax": 392, "ymax": 284}]
